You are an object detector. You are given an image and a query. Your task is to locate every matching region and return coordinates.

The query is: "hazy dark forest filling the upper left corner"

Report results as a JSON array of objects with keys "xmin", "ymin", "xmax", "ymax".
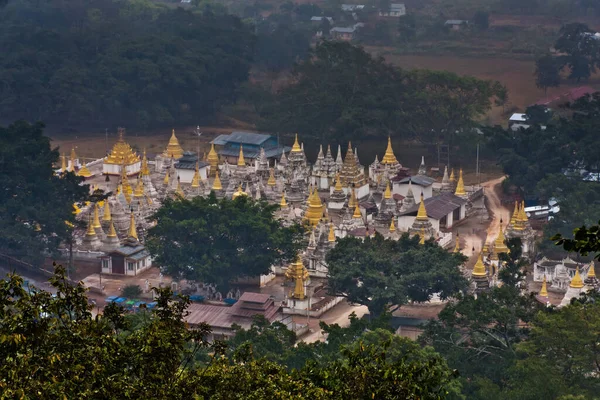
[{"xmin": 0, "ymin": 0, "xmax": 254, "ymax": 127}]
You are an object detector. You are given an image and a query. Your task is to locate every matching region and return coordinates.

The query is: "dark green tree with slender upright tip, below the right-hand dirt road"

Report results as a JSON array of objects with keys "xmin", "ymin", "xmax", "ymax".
[{"xmin": 420, "ymin": 239, "xmax": 542, "ymax": 399}]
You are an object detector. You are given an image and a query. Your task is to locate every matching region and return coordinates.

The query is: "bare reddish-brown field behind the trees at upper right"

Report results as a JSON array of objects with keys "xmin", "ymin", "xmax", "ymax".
[{"xmin": 368, "ymin": 47, "xmax": 600, "ymax": 124}]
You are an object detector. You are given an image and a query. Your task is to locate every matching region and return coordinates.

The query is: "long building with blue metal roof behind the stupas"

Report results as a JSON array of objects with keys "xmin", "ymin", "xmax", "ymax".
[{"xmin": 211, "ymin": 132, "xmax": 291, "ymax": 161}]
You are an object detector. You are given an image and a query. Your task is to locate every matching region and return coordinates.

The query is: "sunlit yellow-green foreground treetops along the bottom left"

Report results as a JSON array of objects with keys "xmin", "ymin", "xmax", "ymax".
[{"xmin": 0, "ymin": 267, "xmax": 456, "ymax": 400}]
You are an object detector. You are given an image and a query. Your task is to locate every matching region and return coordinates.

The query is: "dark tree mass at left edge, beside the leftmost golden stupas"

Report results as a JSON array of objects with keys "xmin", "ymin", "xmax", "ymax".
[{"xmin": 0, "ymin": 121, "xmax": 89, "ymax": 263}]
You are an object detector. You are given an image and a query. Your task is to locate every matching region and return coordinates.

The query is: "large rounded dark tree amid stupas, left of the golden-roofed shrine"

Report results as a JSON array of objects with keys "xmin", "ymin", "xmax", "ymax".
[{"xmin": 146, "ymin": 193, "xmax": 303, "ymax": 290}]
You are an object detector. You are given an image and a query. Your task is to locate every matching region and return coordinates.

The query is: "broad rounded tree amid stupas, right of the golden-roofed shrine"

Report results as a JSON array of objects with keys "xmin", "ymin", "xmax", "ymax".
[{"xmin": 327, "ymin": 234, "xmax": 466, "ymax": 316}]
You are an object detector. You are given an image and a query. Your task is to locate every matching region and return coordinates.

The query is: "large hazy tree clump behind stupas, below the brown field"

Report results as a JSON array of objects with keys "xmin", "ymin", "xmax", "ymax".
[{"xmin": 260, "ymin": 41, "xmax": 505, "ymax": 142}]
